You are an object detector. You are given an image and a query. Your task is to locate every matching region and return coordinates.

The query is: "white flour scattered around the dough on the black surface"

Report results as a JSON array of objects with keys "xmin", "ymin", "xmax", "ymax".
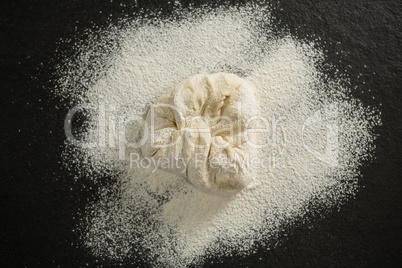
[{"xmin": 57, "ymin": 4, "xmax": 380, "ymax": 267}]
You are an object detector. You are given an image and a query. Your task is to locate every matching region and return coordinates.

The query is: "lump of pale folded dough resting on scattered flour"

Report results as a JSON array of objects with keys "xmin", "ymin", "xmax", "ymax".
[{"xmin": 141, "ymin": 73, "xmax": 257, "ymax": 195}]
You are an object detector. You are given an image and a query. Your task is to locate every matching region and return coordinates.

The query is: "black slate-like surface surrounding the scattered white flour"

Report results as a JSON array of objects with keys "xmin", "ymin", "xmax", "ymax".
[{"xmin": 0, "ymin": 0, "xmax": 402, "ymax": 267}]
